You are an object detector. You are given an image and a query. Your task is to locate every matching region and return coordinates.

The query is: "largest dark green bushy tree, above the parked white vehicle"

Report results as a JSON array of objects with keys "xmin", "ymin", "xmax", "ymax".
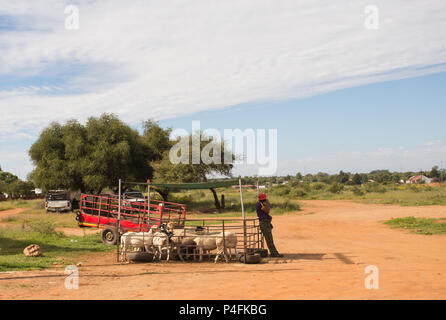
[{"xmin": 29, "ymin": 114, "xmax": 155, "ymax": 193}]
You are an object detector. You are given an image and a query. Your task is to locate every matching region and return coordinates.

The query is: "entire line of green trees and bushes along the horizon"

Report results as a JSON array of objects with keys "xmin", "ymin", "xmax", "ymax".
[{"xmin": 0, "ymin": 114, "xmax": 446, "ymax": 202}]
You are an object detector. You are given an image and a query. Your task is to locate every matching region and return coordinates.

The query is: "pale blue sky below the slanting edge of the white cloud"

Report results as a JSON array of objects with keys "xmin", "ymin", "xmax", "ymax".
[{"xmin": 0, "ymin": 73, "xmax": 446, "ymax": 176}]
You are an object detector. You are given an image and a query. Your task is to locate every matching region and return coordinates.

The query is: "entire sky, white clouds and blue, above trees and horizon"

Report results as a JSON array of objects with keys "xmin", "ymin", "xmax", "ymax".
[{"xmin": 0, "ymin": 0, "xmax": 446, "ymax": 178}]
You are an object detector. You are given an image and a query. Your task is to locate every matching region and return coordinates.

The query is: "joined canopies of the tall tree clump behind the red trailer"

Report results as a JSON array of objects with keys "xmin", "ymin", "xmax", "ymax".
[{"xmin": 29, "ymin": 114, "xmax": 235, "ymax": 199}]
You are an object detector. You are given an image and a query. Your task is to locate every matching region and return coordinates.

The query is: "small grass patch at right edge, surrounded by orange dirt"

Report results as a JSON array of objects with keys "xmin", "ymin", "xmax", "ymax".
[{"xmin": 384, "ymin": 217, "xmax": 446, "ymax": 235}]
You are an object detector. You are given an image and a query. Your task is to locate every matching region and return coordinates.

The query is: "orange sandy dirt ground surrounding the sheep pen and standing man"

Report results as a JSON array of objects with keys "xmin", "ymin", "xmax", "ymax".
[{"xmin": 0, "ymin": 201, "xmax": 446, "ymax": 299}]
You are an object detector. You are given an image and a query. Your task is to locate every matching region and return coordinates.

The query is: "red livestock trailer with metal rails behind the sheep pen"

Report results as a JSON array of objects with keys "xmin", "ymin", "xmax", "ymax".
[{"xmin": 76, "ymin": 194, "xmax": 186, "ymax": 245}]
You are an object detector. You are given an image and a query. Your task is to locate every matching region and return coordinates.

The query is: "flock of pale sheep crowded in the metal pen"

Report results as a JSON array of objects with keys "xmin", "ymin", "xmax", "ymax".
[{"xmin": 121, "ymin": 222, "xmax": 237, "ymax": 263}]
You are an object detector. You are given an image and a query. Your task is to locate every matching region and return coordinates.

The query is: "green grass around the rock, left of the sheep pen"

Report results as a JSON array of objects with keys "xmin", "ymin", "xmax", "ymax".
[{"xmin": 0, "ymin": 227, "xmax": 111, "ymax": 272}]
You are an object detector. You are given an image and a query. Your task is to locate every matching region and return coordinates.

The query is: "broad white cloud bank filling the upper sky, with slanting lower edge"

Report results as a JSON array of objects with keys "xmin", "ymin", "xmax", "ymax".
[{"xmin": 0, "ymin": 0, "xmax": 446, "ymax": 141}]
